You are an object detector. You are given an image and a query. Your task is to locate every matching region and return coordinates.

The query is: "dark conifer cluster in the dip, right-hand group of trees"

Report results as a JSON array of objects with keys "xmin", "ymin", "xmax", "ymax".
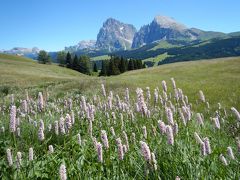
[{"xmin": 99, "ymin": 56, "xmax": 146, "ymax": 76}]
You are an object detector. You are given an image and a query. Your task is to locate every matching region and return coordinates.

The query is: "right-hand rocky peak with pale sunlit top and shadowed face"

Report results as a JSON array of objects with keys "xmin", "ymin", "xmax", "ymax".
[{"xmin": 132, "ymin": 16, "xmax": 199, "ymax": 48}]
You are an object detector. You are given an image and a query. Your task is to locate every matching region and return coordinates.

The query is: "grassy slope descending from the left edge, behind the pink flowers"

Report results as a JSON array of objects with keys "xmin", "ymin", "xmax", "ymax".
[{"xmin": 0, "ymin": 54, "xmax": 95, "ymax": 93}]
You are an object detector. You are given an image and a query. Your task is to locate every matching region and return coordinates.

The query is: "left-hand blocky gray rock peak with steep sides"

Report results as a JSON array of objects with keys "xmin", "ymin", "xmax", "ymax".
[{"xmin": 96, "ymin": 18, "xmax": 137, "ymax": 51}]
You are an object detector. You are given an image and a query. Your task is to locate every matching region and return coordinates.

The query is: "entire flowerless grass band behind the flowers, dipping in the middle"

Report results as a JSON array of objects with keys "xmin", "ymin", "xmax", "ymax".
[{"xmin": 0, "ymin": 55, "xmax": 240, "ymax": 106}]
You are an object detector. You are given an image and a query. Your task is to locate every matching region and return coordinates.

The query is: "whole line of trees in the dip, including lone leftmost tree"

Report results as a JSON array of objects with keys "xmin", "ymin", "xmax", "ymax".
[{"xmin": 38, "ymin": 51, "xmax": 146, "ymax": 76}]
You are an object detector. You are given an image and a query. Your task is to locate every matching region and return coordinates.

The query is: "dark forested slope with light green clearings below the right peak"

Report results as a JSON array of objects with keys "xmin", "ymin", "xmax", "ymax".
[{"xmin": 114, "ymin": 37, "xmax": 240, "ymax": 64}]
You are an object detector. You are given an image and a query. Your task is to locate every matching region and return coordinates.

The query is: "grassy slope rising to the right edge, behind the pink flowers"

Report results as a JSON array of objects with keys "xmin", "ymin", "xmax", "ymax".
[{"xmin": 107, "ymin": 57, "xmax": 240, "ymax": 108}]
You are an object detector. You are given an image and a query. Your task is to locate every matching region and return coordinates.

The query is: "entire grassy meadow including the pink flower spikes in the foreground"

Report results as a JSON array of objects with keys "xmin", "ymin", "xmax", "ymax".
[{"xmin": 0, "ymin": 55, "xmax": 240, "ymax": 179}]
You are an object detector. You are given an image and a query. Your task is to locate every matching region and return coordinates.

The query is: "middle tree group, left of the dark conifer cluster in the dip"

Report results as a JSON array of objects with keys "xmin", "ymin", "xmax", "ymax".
[{"xmin": 57, "ymin": 51, "xmax": 92, "ymax": 75}]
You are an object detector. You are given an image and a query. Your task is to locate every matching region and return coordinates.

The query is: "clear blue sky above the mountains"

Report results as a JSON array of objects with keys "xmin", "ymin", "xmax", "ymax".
[{"xmin": 0, "ymin": 0, "xmax": 240, "ymax": 51}]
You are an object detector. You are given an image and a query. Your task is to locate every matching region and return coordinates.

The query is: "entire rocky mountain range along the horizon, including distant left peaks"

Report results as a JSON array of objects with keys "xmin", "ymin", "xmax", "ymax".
[{"xmin": 0, "ymin": 16, "xmax": 240, "ymax": 58}]
